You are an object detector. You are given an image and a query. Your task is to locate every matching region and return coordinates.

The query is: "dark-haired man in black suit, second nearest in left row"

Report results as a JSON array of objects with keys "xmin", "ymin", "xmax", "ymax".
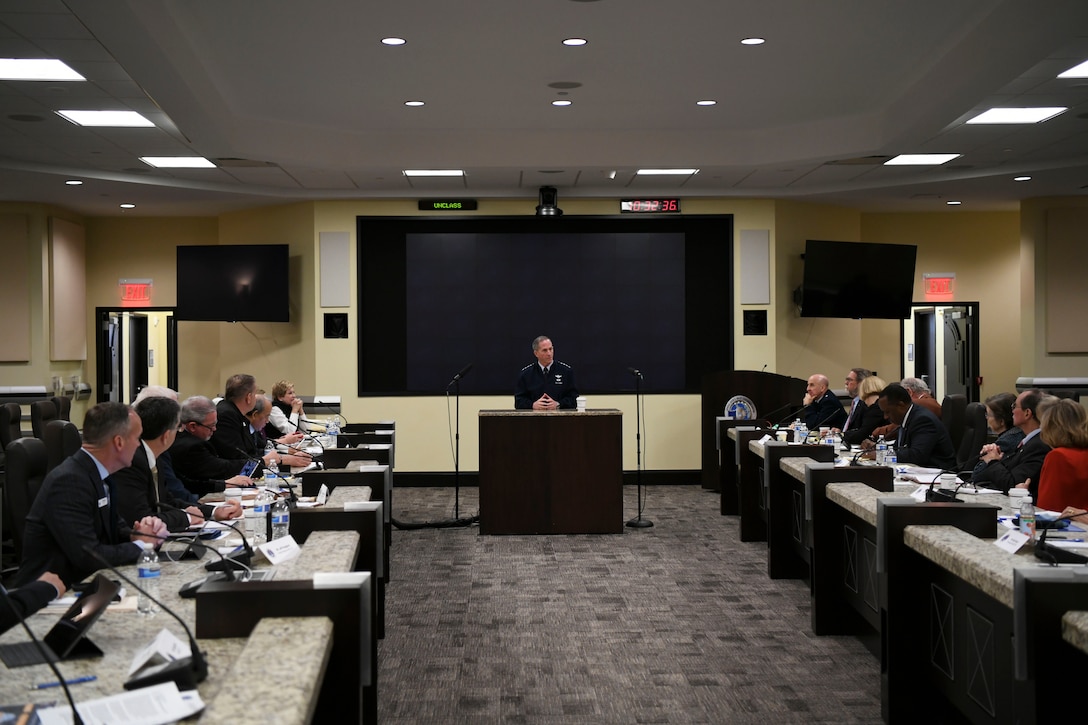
[{"xmin": 110, "ymin": 397, "xmax": 242, "ymax": 531}]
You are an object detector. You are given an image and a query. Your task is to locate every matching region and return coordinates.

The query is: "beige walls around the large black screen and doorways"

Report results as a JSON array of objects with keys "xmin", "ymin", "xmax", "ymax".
[{"xmin": 0, "ymin": 194, "xmax": 1057, "ymax": 471}]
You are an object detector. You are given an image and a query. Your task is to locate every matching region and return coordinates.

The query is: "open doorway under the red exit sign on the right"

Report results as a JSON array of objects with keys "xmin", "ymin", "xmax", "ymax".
[{"xmin": 902, "ymin": 303, "xmax": 979, "ymax": 403}]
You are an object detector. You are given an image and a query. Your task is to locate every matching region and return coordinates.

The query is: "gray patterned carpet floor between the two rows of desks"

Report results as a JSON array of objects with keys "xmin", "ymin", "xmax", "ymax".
[{"xmin": 379, "ymin": 486, "xmax": 880, "ymax": 724}]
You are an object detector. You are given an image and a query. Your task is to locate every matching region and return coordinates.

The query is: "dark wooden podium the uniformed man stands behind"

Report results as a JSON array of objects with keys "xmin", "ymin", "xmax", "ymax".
[{"xmin": 480, "ymin": 409, "xmax": 623, "ymax": 533}]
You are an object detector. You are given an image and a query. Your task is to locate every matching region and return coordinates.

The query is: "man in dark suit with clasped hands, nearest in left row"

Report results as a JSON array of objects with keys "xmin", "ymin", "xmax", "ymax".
[{"xmin": 15, "ymin": 403, "xmax": 166, "ymax": 586}]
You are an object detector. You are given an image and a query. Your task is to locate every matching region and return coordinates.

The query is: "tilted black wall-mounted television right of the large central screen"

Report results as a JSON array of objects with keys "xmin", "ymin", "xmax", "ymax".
[{"xmin": 801, "ymin": 239, "xmax": 918, "ymax": 320}]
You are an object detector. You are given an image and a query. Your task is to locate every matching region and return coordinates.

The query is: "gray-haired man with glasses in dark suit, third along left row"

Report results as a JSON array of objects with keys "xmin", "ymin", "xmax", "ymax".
[{"xmin": 170, "ymin": 395, "xmax": 254, "ymax": 495}]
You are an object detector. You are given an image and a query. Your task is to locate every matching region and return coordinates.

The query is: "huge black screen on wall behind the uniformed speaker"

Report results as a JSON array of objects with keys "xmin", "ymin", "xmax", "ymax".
[{"xmin": 359, "ymin": 217, "xmax": 732, "ymax": 401}]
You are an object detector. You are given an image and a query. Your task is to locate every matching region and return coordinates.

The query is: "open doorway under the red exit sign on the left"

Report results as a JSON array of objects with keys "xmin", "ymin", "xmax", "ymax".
[{"xmin": 95, "ymin": 307, "xmax": 177, "ymax": 403}]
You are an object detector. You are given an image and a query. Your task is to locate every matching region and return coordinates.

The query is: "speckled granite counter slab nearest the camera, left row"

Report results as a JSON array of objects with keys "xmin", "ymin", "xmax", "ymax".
[{"xmin": 200, "ymin": 617, "xmax": 333, "ymax": 725}]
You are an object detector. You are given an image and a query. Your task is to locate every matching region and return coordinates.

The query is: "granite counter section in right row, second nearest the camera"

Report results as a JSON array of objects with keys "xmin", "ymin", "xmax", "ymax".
[{"xmin": 903, "ymin": 526, "xmax": 1037, "ymax": 609}]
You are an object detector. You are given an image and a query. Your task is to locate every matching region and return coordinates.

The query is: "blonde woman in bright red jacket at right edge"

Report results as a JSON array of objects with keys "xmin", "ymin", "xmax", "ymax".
[{"xmin": 1038, "ymin": 398, "xmax": 1088, "ymax": 512}]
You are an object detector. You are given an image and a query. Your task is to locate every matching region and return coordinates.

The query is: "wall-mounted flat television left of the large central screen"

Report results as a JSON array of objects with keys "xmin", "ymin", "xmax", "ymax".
[{"xmin": 175, "ymin": 244, "xmax": 290, "ymax": 322}]
